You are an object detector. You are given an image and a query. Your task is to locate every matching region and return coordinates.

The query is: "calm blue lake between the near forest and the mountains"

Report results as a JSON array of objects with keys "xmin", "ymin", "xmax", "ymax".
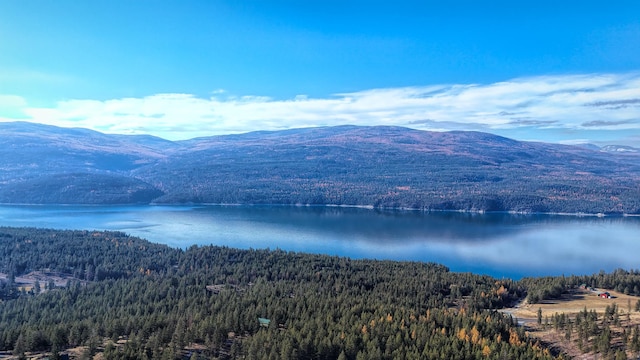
[{"xmin": 0, "ymin": 206, "xmax": 640, "ymax": 279}]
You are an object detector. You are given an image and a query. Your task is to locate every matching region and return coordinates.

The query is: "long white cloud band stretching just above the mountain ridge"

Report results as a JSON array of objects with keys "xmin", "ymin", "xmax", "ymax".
[{"xmin": 0, "ymin": 73, "xmax": 640, "ymax": 139}]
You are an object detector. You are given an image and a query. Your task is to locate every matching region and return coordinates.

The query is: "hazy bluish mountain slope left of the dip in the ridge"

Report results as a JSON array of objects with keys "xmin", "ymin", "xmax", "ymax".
[{"xmin": 0, "ymin": 122, "xmax": 170, "ymax": 204}]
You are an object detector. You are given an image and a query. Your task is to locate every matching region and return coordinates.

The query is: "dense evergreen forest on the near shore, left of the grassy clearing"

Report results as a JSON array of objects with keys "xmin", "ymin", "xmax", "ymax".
[{"xmin": 0, "ymin": 228, "xmax": 553, "ymax": 359}]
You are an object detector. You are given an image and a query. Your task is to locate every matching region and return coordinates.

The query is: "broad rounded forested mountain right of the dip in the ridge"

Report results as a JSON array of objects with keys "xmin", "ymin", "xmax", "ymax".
[{"xmin": 139, "ymin": 126, "xmax": 640, "ymax": 213}]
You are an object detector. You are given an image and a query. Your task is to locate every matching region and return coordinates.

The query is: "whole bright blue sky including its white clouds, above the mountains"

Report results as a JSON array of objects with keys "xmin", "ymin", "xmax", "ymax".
[{"xmin": 0, "ymin": 0, "xmax": 640, "ymax": 146}]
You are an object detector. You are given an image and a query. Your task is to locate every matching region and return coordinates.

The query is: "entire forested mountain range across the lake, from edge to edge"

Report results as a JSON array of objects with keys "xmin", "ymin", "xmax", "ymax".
[{"xmin": 0, "ymin": 123, "xmax": 640, "ymax": 214}]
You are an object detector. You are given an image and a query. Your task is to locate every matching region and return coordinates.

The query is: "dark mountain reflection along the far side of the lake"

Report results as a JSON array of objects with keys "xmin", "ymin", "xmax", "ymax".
[{"xmin": 190, "ymin": 206, "xmax": 640, "ymax": 243}]
